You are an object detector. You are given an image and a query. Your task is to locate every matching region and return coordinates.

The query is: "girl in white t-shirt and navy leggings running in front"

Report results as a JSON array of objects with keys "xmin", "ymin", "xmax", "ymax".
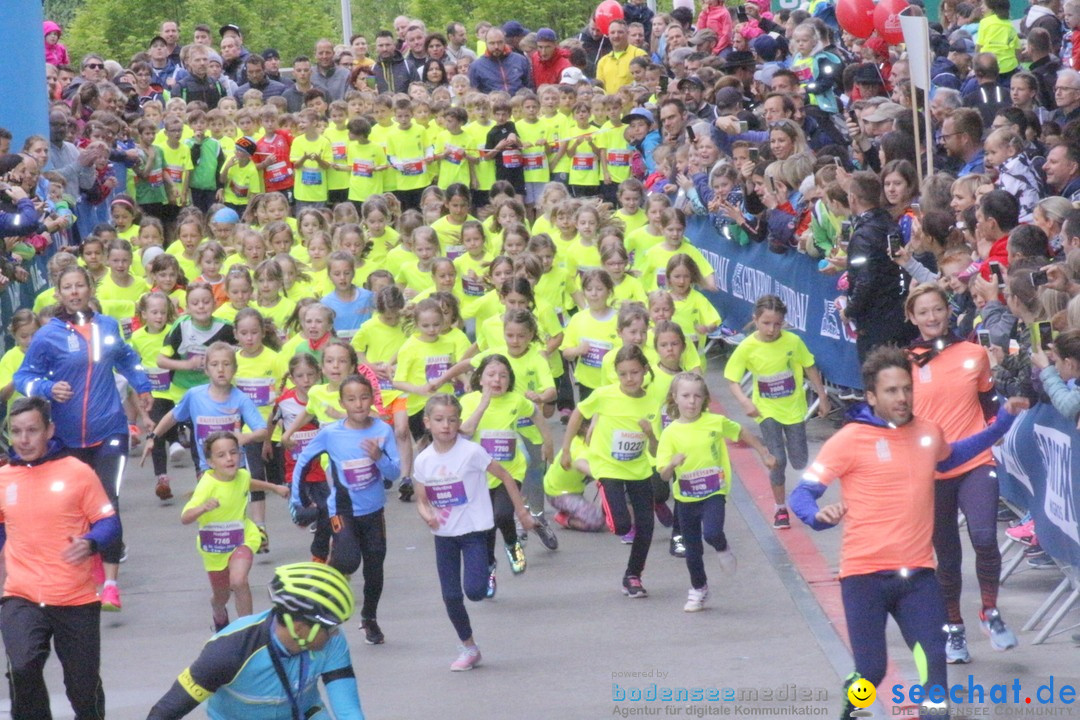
[{"xmin": 413, "ymin": 393, "xmax": 535, "ymax": 673}]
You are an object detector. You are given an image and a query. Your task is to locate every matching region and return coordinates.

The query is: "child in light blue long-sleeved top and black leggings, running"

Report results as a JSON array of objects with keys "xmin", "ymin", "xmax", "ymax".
[{"xmin": 291, "ymin": 375, "xmax": 401, "ymax": 644}]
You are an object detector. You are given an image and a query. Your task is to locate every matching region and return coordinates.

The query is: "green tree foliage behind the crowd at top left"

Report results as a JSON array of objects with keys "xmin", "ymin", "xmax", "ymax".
[{"xmin": 65, "ymin": 0, "xmax": 341, "ymax": 64}]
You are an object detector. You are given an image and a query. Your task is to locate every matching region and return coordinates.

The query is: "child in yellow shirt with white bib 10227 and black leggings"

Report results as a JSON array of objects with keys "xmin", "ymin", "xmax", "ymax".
[{"xmin": 561, "ymin": 345, "xmax": 658, "ymax": 598}]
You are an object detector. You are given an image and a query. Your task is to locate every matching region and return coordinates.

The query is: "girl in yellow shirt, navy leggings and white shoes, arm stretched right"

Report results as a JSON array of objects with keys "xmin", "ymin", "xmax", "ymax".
[{"xmin": 657, "ymin": 372, "xmax": 777, "ymax": 612}]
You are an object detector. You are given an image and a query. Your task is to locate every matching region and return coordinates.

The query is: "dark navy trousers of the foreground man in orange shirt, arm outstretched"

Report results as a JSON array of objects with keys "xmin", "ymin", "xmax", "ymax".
[{"xmin": 840, "ymin": 568, "xmax": 948, "ymax": 688}]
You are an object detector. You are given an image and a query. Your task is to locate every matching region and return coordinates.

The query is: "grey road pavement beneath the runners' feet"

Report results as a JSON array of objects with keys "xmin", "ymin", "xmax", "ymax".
[{"xmin": 0, "ymin": 362, "xmax": 1080, "ymax": 720}]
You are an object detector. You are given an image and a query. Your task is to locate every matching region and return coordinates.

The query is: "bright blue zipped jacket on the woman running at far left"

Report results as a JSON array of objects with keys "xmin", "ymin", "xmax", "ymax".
[{"xmin": 14, "ymin": 313, "xmax": 150, "ymax": 448}]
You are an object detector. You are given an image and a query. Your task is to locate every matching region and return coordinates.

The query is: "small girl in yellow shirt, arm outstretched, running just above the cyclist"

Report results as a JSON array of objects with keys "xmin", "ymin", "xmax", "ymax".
[{"xmin": 180, "ymin": 431, "xmax": 288, "ymax": 633}]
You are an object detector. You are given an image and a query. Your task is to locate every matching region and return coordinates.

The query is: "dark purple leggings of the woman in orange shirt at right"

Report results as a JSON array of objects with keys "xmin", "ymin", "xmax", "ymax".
[{"xmin": 934, "ymin": 465, "xmax": 1001, "ymax": 625}]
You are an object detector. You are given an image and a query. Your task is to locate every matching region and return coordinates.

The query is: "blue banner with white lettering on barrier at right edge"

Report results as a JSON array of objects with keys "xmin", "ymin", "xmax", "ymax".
[{"xmin": 995, "ymin": 403, "xmax": 1080, "ymax": 568}]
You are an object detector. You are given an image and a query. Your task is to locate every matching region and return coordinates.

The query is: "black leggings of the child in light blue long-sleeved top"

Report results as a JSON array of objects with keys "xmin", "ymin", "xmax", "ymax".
[{"xmin": 329, "ymin": 508, "xmax": 387, "ymax": 620}]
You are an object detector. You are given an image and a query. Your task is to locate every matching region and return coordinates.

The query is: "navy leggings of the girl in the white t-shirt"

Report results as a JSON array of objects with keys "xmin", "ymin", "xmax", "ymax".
[{"xmin": 435, "ymin": 530, "xmax": 487, "ymax": 642}]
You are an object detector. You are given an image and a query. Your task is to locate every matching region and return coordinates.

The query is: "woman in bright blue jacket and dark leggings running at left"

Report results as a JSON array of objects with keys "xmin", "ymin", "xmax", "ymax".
[{"xmin": 15, "ymin": 266, "xmax": 153, "ymax": 612}]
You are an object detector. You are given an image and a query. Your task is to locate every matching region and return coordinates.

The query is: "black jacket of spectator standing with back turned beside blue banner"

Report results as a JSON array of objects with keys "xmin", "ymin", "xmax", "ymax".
[{"xmin": 845, "ymin": 207, "xmax": 912, "ymax": 344}]
